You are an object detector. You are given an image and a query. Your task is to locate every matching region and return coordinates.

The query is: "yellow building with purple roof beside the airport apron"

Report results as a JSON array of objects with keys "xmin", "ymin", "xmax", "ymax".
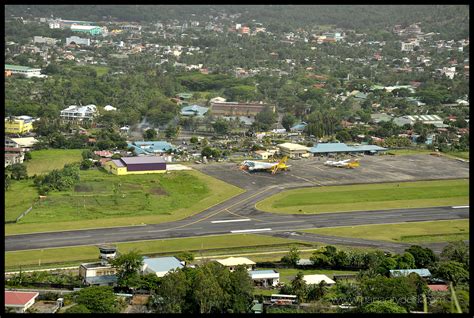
[{"xmin": 104, "ymin": 157, "xmax": 166, "ymax": 176}]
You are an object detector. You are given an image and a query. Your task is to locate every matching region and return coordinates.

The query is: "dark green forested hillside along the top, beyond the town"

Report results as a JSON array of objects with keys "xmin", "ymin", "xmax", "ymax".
[{"xmin": 5, "ymin": 5, "xmax": 469, "ymax": 38}]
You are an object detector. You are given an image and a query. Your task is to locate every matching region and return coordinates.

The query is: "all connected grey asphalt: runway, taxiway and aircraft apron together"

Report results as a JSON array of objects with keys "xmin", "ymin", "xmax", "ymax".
[{"xmin": 5, "ymin": 155, "xmax": 469, "ymax": 251}]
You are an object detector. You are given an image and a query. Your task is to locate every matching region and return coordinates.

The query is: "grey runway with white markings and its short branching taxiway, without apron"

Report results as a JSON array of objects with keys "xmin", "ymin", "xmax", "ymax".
[{"xmin": 5, "ymin": 199, "xmax": 469, "ymax": 251}]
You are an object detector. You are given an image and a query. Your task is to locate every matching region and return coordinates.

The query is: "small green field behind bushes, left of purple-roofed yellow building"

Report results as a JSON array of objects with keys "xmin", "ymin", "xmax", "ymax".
[{"xmin": 26, "ymin": 149, "xmax": 84, "ymax": 176}]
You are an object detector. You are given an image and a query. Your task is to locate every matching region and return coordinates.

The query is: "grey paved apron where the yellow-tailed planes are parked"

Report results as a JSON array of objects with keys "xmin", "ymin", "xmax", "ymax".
[{"xmin": 193, "ymin": 155, "xmax": 469, "ymax": 190}]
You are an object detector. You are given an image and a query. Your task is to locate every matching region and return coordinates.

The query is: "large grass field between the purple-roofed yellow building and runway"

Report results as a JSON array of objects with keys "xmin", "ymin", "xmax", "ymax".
[{"xmin": 5, "ymin": 170, "xmax": 244, "ymax": 235}]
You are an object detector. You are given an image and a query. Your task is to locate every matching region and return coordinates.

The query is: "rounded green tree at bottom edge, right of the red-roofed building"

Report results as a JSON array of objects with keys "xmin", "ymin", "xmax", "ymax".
[{"xmin": 75, "ymin": 286, "xmax": 119, "ymax": 313}]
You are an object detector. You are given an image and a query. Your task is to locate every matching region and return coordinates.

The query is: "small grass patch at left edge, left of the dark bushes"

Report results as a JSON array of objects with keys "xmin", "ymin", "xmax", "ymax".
[{"xmin": 5, "ymin": 180, "xmax": 38, "ymax": 221}]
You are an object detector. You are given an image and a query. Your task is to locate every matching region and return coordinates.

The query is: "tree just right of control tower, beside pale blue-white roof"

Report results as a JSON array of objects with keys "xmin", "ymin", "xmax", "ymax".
[{"xmin": 110, "ymin": 250, "xmax": 143, "ymax": 287}]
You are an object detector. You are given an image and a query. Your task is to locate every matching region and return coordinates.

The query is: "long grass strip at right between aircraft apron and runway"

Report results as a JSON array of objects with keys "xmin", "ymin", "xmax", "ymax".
[{"xmin": 256, "ymin": 179, "xmax": 469, "ymax": 214}]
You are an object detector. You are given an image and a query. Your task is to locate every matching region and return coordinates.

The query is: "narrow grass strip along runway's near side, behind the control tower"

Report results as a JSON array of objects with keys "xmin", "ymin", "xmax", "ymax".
[{"xmin": 5, "ymin": 234, "xmax": 298, "ymax": 269}]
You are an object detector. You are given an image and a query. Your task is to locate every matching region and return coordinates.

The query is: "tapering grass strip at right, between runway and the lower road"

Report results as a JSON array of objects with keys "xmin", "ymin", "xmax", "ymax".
[{"xmin": 303, "ymin": 220, "xmax": 469, "ymax": 243}]
